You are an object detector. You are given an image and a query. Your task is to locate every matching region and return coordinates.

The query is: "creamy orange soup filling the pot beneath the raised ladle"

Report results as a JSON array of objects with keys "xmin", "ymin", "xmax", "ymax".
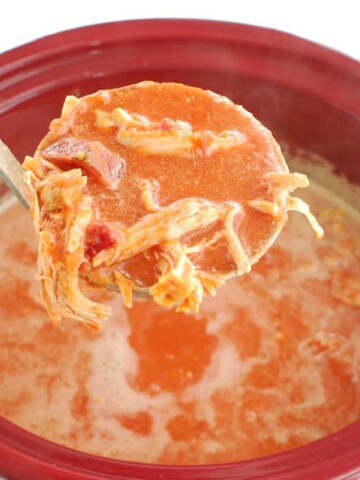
[{"xmin": 0, "ymin": 167, "xmax": 360, "ymax": 464}]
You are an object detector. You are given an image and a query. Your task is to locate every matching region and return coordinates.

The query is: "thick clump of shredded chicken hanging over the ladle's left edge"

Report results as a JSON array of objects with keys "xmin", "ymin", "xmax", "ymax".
[{"xmin": 24, "ymin": 166, "xmax": 111, "ymax": 329}]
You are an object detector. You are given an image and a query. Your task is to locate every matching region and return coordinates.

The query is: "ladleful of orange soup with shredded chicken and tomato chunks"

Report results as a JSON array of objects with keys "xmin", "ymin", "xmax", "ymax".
[{"xmin": 23, "ymin": 81, "xmax": 323, "ymax": 329}]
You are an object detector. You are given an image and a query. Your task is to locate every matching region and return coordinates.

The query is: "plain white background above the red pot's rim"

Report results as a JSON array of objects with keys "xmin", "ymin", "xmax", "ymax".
[{"xmin": 0, "ymin": 0, "xmax": 360, "ymax": 63}]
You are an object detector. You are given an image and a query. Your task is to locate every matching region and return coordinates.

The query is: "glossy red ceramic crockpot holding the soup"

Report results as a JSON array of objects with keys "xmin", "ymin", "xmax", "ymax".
[{"xmin": 0, "ymin": 20, "xmax": 360, "ymax": 480}]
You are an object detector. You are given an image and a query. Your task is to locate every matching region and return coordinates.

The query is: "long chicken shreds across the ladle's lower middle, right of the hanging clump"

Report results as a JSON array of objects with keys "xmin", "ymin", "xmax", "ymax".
[{"xmin": 87, "ymin": 180, "xmax": 251, "ymax": 311}]
